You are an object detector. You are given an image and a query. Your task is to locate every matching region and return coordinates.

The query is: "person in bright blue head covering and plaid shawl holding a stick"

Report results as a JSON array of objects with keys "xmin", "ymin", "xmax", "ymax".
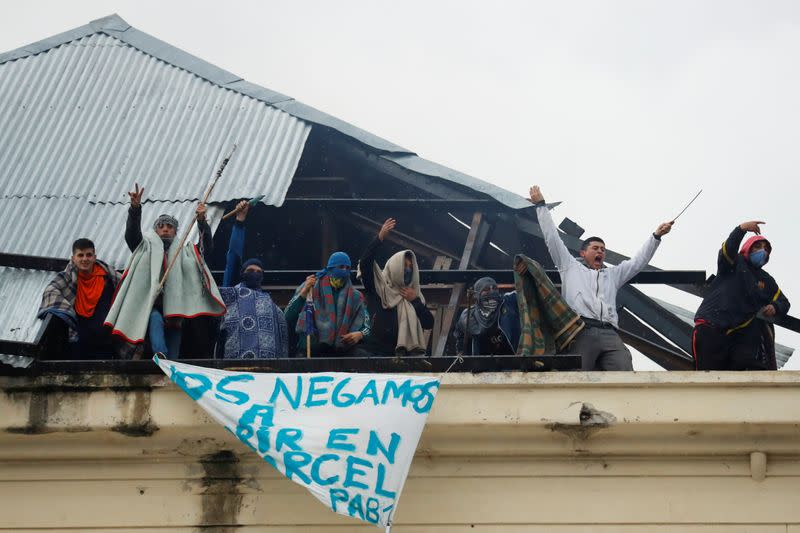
[{"xmin": 285, "ymin": 252, "xmax": 370, "ymax": 357}]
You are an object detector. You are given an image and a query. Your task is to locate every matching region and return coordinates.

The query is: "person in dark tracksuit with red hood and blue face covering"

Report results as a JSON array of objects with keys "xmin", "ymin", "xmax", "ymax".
[{"xmin": 692, "ymin": 220, "xmax": 789, "ymax": 370}]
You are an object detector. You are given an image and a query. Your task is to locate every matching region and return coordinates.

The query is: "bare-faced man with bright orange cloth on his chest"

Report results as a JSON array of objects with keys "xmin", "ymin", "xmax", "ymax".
[{"xmin": 39, "ymin": 239, "xmax": 120, "ymax": 359}]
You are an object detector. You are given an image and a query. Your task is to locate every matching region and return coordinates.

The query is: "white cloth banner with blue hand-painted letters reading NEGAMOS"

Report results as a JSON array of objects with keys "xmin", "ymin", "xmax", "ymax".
[{"xmin": 153, "ymin": 357, "xmax": 439, "ymax": 526}]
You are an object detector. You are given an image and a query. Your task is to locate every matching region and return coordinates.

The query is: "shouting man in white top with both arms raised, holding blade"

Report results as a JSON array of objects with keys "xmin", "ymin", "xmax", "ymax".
[{"xmin": 530, "ymin": 185, "xmax": 675, "ymax": 370}]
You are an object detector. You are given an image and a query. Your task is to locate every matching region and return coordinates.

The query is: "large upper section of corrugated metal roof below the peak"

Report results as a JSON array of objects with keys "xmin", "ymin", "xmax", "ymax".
[{"xmin": 0, "ymin": 33, "xmax": 310, "ymax": 205}]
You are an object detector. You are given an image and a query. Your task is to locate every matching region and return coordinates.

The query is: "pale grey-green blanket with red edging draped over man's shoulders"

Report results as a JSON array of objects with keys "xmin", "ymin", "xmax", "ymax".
[{"xmin": 106, "ymin": 231, "xmax": 225, "ymax": 343}]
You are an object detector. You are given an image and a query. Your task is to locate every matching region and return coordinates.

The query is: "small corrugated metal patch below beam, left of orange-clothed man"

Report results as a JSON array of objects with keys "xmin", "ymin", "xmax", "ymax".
[{"xmin": 0, "ymin": 267, "xmax": 54, "ymax": 343}]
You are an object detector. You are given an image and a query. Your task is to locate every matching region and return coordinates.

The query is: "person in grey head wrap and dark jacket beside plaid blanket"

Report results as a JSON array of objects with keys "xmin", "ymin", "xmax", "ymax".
[{"xmin": 453, "ymin": 278, "xmax": 520, "ymax": 355}]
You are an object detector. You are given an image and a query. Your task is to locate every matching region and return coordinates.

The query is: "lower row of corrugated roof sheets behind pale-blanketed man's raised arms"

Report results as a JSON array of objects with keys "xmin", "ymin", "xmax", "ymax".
[{"xmin": 0, "ymin": 198, "xmax": 222, "ymax": 269}]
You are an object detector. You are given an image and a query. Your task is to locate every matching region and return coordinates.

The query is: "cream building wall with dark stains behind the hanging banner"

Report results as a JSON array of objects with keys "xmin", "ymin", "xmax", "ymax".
[{"xmin": 0, "ymin": 372, "xmax": 800, "ymax": 533}]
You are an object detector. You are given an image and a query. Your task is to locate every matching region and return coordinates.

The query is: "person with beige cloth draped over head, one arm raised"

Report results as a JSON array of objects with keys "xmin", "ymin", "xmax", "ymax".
[{"xmin": 359, "ymin": 218, "xmax": 433, "ymax": 356}]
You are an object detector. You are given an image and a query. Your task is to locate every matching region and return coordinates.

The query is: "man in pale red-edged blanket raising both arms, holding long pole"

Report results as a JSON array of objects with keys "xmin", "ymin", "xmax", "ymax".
[{"xmin": 106, "ymin": 184, "xmax": 225, "ymax": 358}]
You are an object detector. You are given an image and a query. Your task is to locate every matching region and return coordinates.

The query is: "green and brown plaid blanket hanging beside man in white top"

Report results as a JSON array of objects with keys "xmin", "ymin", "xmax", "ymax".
[{"xmin": 514, "ymin": 255, "xmax": 584, "ymax": 355}]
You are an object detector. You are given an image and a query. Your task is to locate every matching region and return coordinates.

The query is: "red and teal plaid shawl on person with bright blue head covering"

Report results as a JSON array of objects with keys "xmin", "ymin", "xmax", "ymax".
[{"xmin": 295, "ymin": 275, "xmax": 365, "ymax": 349}]
